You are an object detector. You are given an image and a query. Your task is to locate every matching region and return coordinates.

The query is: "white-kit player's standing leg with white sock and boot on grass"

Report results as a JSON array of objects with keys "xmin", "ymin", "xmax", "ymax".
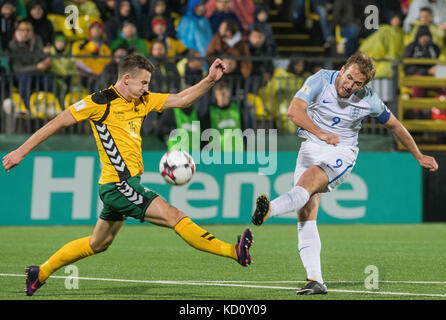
[{"xmin": 296, "ymin": 193, "xmax": 327, "ymax": 295}]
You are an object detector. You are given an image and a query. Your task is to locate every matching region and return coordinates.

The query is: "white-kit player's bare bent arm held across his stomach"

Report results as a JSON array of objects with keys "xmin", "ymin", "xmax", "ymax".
[{"xmin": 287, "ymin": 98, "xmax": 339, "ymax": 146}]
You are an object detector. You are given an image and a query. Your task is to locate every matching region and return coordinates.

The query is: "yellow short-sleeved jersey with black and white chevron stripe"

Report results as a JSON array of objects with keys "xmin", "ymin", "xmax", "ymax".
[{"xmin": 69, "ymin": 86, "xmax": 169, "ymax": 184}]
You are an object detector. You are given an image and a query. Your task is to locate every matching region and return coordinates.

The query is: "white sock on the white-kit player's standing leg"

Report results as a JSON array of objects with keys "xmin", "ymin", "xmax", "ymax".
[{"xmin": 297, "ymin": 220, "xmax": 324, "ymax": 283}]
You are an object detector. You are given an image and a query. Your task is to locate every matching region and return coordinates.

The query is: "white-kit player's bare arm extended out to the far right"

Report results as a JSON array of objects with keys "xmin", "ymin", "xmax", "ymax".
[{"xmin": 384, "ymin": 114, "xmax": 438, "ymax": 171}]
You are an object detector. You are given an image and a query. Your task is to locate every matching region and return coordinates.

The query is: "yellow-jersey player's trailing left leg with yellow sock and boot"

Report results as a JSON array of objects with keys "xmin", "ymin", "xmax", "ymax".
[{"xmin": 25, "ymin": 218, "xmax": 124, "ymax": 296}]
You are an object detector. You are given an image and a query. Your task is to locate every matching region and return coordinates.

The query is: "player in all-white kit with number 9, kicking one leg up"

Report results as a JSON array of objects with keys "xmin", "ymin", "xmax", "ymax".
[{"xmin": 252, "ymin": 52, "xmax": 438, "ymax": 294}]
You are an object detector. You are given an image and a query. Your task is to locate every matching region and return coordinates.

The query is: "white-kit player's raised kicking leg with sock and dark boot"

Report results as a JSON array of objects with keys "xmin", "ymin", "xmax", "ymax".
[{"xmin": 252, "ymin": 165, "xmax": 329, "ymax": 225}]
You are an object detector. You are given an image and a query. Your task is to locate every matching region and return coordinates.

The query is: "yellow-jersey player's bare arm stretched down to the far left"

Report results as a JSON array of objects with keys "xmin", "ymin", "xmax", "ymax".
[{"xmin": 3, "ymin": 109, "xmax": 76, "ymax": 172}]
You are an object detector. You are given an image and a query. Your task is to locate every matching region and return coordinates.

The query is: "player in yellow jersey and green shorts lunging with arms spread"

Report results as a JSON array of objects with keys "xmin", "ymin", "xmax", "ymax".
[{"xmin": 3, "ymin": 54, "xmax": 252, "ymax": 296}]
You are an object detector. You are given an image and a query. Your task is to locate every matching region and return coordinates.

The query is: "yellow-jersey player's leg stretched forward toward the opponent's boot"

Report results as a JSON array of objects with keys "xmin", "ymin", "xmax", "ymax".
[{"xmin": 144, "ymin": 197, "xmax": 253, "ymax": 266}]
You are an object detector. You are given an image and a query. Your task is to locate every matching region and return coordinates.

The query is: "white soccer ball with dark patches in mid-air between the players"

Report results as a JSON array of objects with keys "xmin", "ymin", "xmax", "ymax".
[{"xmin": 159, "ymin": 150, "xmax": 195, "ymax": 186}]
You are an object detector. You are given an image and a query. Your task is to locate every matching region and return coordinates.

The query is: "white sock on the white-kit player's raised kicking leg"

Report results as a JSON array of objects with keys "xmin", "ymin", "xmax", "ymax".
[{"xmin": 269, "ymin": 186, "xmax": 310, "ymax": 217}]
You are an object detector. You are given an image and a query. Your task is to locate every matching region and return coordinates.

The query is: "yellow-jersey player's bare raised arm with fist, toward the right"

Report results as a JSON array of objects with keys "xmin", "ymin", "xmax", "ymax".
[{"xmin": 164, "ymin": 59, "xmax": 226, "ymax": 109}]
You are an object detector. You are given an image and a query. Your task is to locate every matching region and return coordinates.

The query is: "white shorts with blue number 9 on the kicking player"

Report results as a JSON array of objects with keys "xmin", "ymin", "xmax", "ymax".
[{"xmin": 294, "ymin": 141, "xmax": 358, "ymax": 191}]
